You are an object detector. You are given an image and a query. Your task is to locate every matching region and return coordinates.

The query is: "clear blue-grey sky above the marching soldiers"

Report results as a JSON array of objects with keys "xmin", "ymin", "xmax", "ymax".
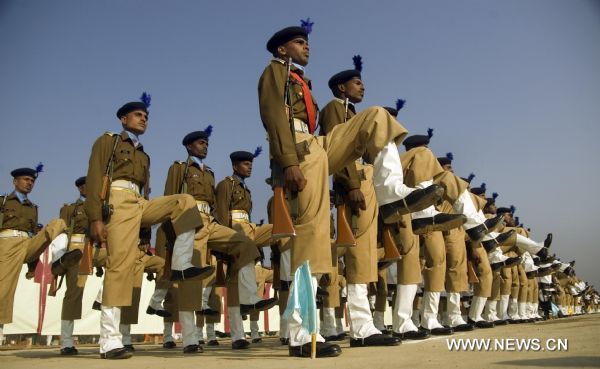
[{"xmin": 0, "ymin": 0, "xmax": 600, "ymax": 287}]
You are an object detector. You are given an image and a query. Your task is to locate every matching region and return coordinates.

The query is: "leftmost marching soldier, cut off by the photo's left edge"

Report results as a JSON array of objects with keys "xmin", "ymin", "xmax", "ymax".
[{"xmin": 0, "ymin": 165, "xmax": 71, "ymax": 340}]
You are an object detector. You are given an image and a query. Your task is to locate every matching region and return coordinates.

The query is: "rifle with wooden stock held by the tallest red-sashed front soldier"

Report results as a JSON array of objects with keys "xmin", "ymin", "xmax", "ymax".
[{"xmin": 271, "ymin": 58, "xmax": 298, "ymax": 239}]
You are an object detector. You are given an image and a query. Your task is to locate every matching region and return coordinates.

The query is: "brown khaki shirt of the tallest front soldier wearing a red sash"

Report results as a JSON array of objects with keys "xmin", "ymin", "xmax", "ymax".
[{"xmin": 258, "ymin": 59, "xmax": 318, "ymax": 168}]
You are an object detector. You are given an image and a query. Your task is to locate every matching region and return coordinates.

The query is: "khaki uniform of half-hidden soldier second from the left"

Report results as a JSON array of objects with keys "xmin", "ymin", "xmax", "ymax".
[{"xmin": 60, "ymin": 199, "xmax": 90, "ymax": 320}]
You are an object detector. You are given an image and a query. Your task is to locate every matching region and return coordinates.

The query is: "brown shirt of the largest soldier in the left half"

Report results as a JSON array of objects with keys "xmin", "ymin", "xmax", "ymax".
[{"xmin": 84, "ymin": 131, "xmax": 150, "ymax": 222}]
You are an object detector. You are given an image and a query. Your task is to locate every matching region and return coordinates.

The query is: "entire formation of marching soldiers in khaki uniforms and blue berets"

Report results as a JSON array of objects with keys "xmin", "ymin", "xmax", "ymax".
[{"xmin": 0, "ymin": 22, "xmax": 598, "ymax": 359}]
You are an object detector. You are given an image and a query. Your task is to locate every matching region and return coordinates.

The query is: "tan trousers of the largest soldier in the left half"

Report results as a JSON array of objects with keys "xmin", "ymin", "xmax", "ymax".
[{"xmin": 102, "ymin": 188, "xmax": 201, "ymax": 307}]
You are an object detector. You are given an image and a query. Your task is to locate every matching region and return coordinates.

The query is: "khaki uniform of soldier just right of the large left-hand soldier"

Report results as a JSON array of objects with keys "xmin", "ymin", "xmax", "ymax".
[{"xmin": 165, "ymin": 161, "xmax": 260, "ymax": 311}]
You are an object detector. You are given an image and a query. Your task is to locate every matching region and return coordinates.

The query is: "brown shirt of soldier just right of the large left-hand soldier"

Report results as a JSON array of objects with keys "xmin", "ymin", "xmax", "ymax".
[{"xmin": 165, "ymin": 160, "xmax": 215, "ymax": 209}]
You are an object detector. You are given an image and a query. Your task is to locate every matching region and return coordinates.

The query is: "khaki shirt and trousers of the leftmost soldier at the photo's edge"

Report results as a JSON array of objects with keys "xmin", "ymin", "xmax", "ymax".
[{"xmin": 0, "ymin": 193, "xmax": 67, "ymax": 324}]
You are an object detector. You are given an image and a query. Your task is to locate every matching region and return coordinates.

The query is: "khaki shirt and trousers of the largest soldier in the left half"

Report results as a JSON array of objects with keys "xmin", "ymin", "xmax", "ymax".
[{"xmin": 85, "ymin": 131, "xmax": 201, "ymax": 307}]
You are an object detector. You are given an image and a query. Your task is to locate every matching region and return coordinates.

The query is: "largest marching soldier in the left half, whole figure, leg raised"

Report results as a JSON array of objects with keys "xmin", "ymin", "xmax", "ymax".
[{"xmin": 85, "ymin": 94, "xmax": 212, "ymax": 359}]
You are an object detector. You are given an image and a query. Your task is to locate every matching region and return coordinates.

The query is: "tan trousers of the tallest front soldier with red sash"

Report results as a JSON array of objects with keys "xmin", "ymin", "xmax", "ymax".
[{"xmin": 291, "ymin": 107, "xmax": 408, "ymax": 274}]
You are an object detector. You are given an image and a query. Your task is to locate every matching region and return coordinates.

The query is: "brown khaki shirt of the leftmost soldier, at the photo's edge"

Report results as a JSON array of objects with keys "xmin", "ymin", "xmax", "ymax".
[{"xmin": 0, "ymin": 192, "xmax": 37, "ymax": 231}]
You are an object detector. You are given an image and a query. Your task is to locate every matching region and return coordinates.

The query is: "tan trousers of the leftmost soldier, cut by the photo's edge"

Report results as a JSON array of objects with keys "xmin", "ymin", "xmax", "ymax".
[{"xmin": 0, "ymin": 219, "xmax": 67, "ymax": 324}]
